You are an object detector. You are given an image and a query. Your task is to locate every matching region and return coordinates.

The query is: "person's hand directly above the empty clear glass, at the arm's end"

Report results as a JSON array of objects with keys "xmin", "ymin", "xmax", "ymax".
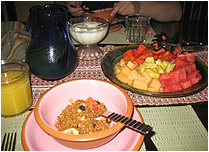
[{"xmin": 111, "ymin": 1, "xmax": 139, "ymax": 16}]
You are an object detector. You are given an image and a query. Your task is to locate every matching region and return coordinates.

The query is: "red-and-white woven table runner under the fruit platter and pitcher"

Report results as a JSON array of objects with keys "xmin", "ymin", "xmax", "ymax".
[{"xmin": 31, "ymin": 45, "xmax": 208, "ymax": 106}]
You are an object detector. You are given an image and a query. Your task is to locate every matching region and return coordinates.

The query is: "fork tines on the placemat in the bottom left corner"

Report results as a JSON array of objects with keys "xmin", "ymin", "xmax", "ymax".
[{"xmin": 1, "ymin": 132, "xmax": 17, "ymax": 151}]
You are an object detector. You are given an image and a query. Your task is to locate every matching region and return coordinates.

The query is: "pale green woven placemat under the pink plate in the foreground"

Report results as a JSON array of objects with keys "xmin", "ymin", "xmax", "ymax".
[{"xmin": 1, "ymin": 105, "xmax": 208, "ymax": 151}]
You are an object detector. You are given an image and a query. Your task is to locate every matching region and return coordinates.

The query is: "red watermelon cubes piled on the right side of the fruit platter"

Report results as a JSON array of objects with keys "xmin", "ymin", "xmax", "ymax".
[{"xmin": 159, "ymin": 49, "xmax": 202, "ymax": 92}]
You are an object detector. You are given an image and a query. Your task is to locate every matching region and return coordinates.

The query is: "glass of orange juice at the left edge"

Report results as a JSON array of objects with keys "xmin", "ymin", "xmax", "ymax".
[{"xmin": 1, "ymin": 60, "xmax": 32, "ymax": 117}]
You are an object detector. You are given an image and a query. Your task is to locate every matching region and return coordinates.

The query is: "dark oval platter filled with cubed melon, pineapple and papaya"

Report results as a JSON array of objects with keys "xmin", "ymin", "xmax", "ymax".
[{"xmin": 102, "ymin": 44, "xmax": 208, "ymax": 98}]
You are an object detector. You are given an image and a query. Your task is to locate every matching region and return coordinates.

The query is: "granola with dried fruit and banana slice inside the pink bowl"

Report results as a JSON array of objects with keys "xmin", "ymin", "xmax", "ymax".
[{"xmin": 55, "ymin": 97, "xmax": 111, "ymax": 134}]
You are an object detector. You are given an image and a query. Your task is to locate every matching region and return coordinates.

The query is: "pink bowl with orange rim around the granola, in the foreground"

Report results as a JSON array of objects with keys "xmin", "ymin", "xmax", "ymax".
[{"xmin": 34, "ymin": 79, "xmax": 133, "ymax": 149}]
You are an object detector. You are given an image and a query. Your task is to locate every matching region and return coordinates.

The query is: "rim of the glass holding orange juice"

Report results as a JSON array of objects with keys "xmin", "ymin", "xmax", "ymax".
[{"xmin": 1, "ymin": 60, "xmax": 29, "ymax": 85}]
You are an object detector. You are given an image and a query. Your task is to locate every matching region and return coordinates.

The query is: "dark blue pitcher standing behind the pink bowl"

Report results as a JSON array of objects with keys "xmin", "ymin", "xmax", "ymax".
[{"xmin": 26, "ymin": 4, "xmax": 78, "ymax": 80}]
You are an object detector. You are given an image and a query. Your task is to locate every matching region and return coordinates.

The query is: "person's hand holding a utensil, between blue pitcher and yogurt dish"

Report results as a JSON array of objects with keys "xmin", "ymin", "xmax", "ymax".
[{"xmin": 67, "ymin": 1, "xmax": 89, "ymax": 16}]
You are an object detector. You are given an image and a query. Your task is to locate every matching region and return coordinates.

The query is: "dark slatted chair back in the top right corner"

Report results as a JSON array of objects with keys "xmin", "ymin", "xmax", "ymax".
[{"xmin": 180, "ymin": 1, "xmax": 208, "ymax": 45}]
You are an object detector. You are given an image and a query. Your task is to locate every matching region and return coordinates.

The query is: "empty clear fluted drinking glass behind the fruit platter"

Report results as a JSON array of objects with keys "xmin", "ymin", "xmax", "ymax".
[{"xmin": 126, "ymin": 14, "xmax": 151, "ymax": 44}]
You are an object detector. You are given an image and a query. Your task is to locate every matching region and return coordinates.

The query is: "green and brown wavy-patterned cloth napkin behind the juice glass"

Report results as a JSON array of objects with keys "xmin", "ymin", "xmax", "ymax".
[{"xmin": 1, "ymin": 21, "xmax": 31, "ymax": 60}]
